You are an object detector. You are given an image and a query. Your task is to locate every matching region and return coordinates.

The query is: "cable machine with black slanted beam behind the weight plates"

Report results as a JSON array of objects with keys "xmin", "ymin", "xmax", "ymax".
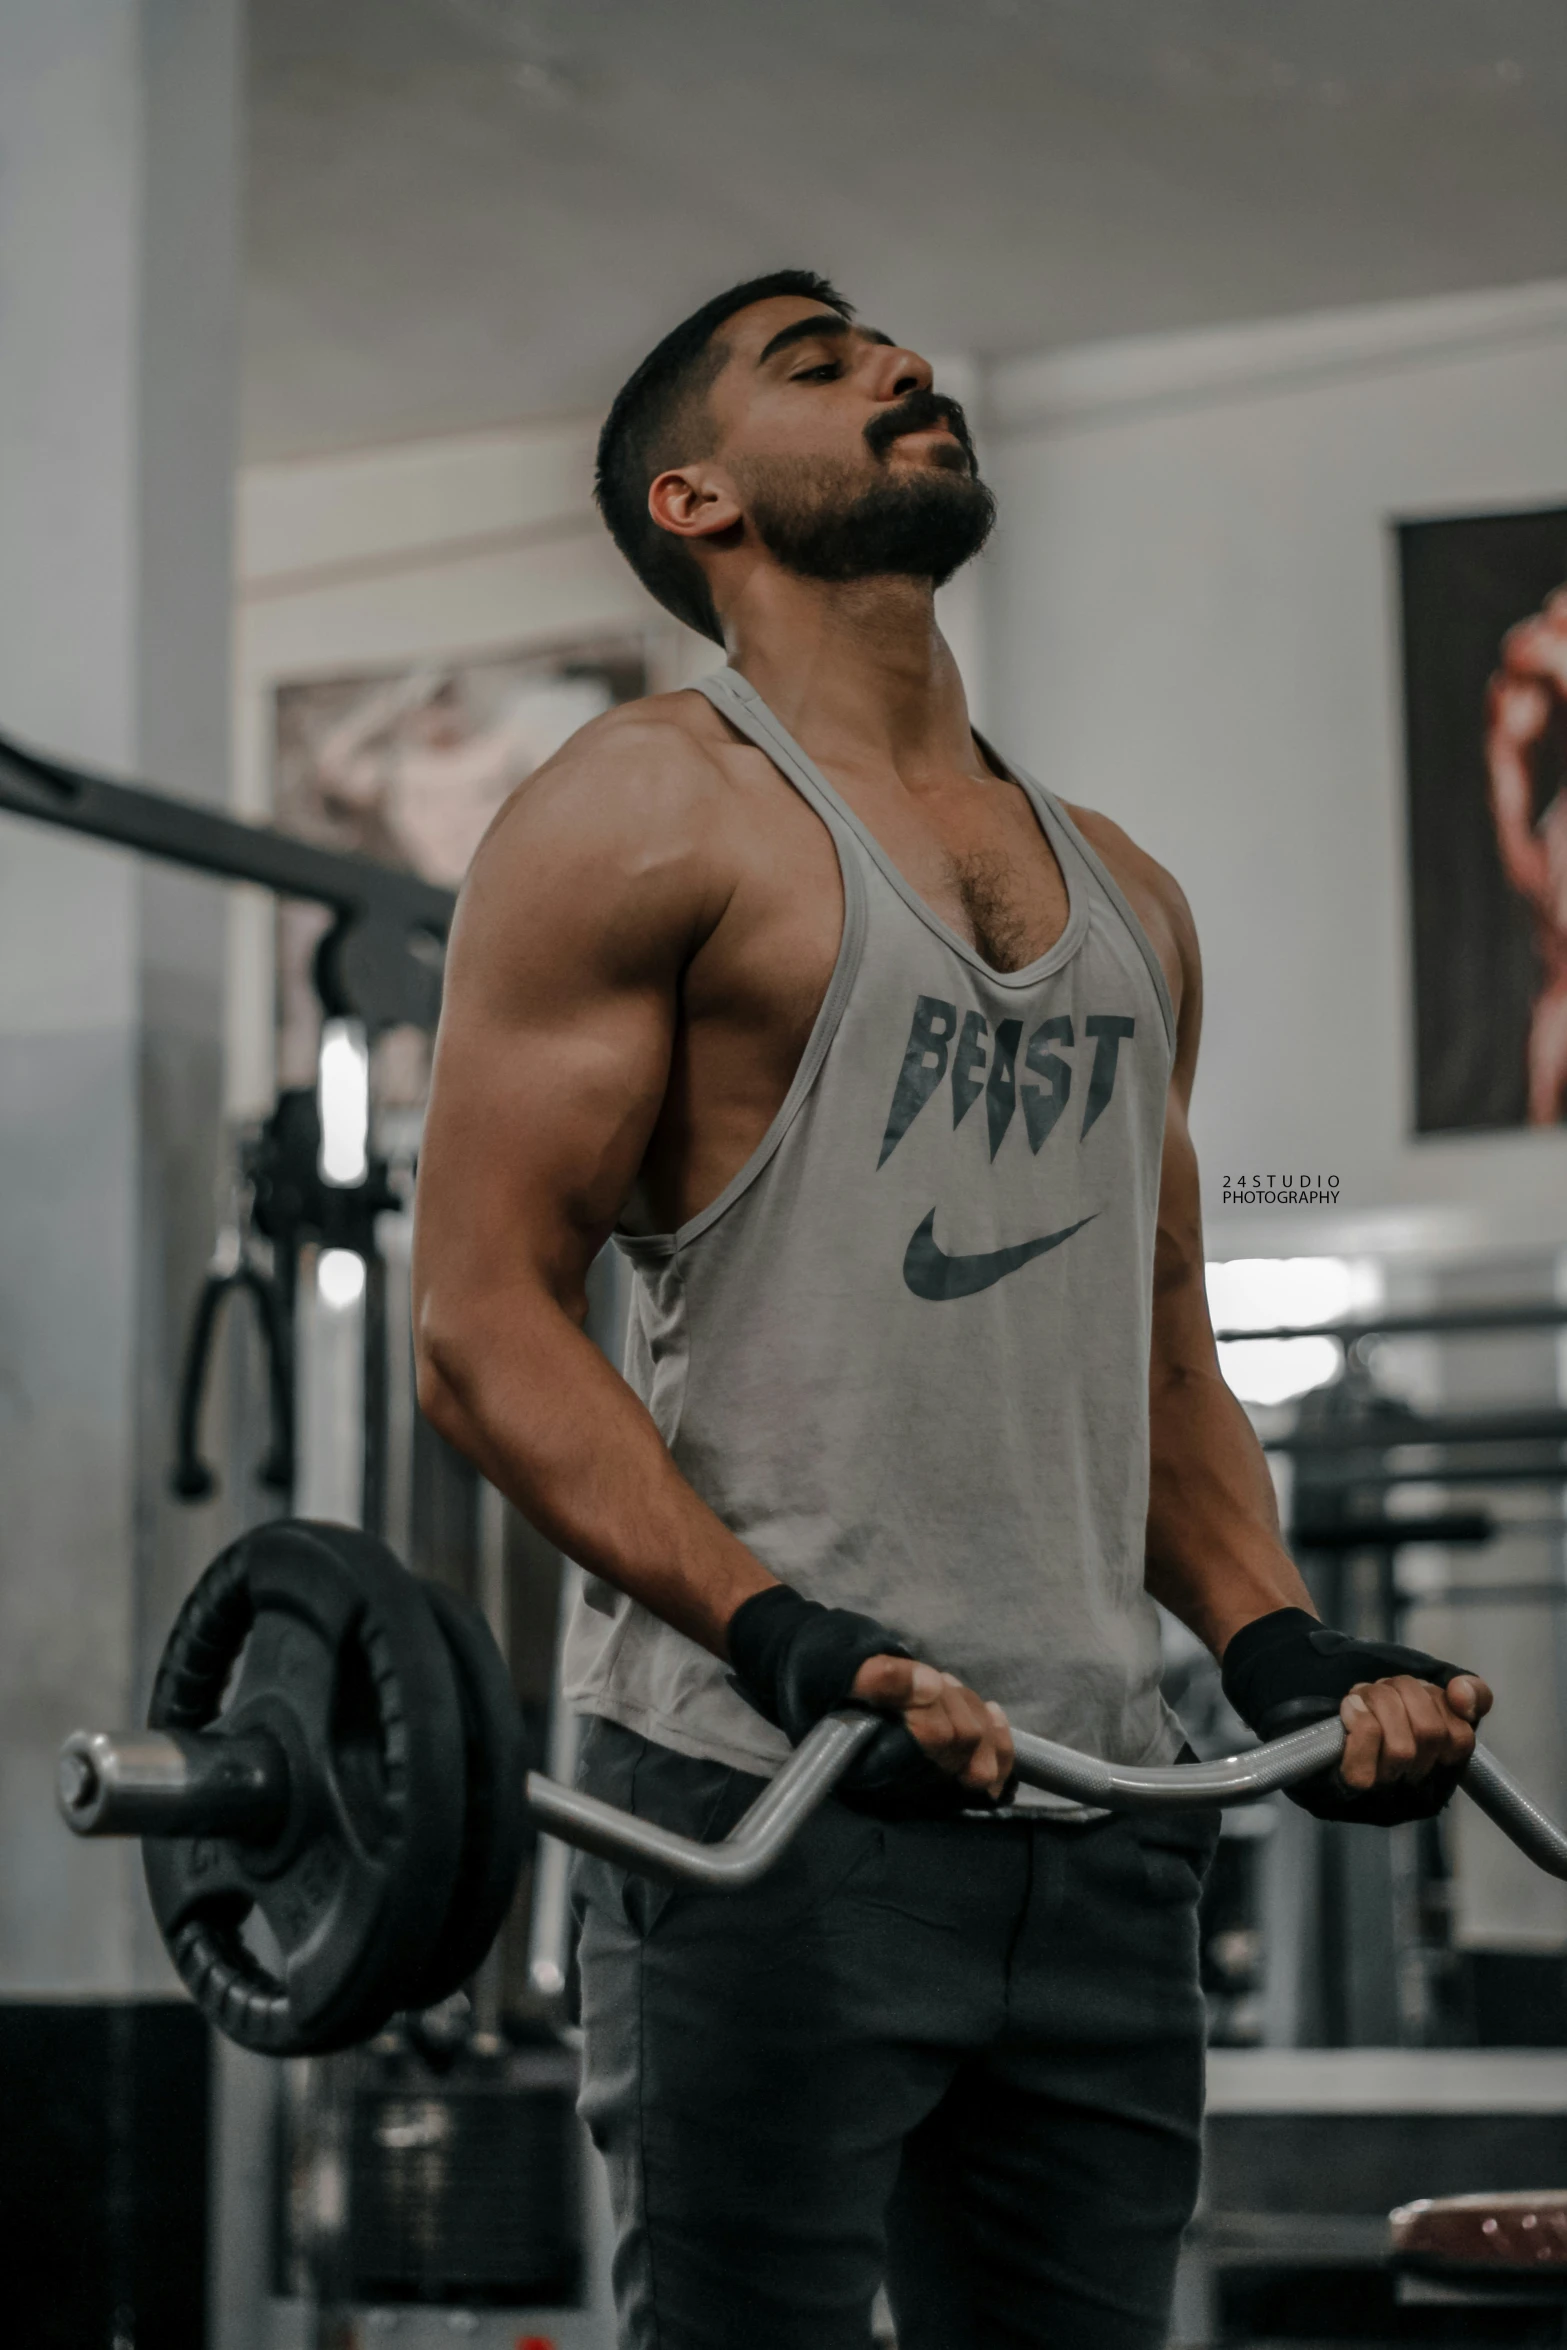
[{"xmin": 0, "ymin": 736, "xmax": 618, "ymax": 2350}]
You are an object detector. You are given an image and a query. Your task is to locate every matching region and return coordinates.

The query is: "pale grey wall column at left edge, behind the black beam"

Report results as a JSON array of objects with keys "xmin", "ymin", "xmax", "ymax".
[{"xmin": 0, "ymin": 0, "xmax": 240, "ymax": 1993}]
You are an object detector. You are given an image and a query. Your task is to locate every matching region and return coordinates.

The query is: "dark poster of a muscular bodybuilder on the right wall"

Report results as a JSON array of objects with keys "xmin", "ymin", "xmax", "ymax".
[{"xmin": 1398, "ymin": 508, "xmax": 1567, "ymax": 1135}]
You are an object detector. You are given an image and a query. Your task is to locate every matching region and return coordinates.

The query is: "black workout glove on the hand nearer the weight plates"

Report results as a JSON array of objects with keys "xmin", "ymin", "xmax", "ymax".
[{"xmin": 728, "ymin": 1584, "xmax": 989, "ymax": 1819}]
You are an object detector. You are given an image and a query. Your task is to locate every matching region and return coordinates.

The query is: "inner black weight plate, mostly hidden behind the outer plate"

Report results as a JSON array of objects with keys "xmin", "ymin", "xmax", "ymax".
[{"xmin": 409, "ymin": 1584, "xmax": 529, "ymax": 2007}]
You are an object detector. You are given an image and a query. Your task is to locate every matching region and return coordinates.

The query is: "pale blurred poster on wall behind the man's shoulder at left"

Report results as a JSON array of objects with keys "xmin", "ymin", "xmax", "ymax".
[{"xmin": 273, "ymin": 639, "xmax": 646, "ymax": 1107}]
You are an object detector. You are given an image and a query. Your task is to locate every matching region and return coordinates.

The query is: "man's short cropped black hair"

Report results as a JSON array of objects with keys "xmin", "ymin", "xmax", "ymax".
[{"xmin": 594, "ymin": 270, "xmax": 855, "ymax": 644}]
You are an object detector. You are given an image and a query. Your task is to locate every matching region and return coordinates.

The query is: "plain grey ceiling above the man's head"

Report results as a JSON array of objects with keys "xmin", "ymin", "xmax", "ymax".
[{"xmin": 244, "ymin": 0, "xmax": 1567, "ymax": 458}]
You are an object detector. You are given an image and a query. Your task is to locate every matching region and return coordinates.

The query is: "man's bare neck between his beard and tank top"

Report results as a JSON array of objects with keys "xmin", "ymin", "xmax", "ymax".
[{"xmin": 724, "ymin": 569, "xmax": 984, "ymax": 783}]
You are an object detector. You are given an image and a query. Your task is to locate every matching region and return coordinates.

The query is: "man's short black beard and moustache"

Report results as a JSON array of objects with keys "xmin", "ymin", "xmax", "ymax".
[{"xmin": 742, "ymin": 390, "xmax": 996, "ymax": 588}]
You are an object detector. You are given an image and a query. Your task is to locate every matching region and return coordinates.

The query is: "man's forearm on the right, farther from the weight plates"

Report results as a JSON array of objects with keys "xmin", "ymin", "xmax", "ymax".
[{"xmin": 1146, "ymin": 1365, "xmax": 1316, "ymax": 1657}]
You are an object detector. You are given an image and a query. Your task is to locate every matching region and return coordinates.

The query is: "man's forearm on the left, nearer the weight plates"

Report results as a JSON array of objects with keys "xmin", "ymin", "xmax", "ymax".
[{"xmin": 418, "ymin": 1293, "xmax": 775, "ymax": 1657}]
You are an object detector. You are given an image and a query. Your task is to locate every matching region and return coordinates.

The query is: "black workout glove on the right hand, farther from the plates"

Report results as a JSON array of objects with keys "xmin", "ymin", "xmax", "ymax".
[{"xmin": 1219, "ymin": 1607, "xmax": 1466, "ymax": 1828}]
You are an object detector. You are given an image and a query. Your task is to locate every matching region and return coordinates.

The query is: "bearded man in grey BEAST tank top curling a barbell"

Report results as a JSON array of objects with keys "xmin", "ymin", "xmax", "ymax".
[{"xmin": 416, "ymin": 273, "xmax": 1489, "ymax": 2350}]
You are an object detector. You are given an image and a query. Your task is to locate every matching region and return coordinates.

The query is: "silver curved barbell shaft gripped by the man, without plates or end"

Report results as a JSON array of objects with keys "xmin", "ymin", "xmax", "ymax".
[{"xmin": 529, "ymin": 1708, "xmax": 1567, "ymax": 1892}]
